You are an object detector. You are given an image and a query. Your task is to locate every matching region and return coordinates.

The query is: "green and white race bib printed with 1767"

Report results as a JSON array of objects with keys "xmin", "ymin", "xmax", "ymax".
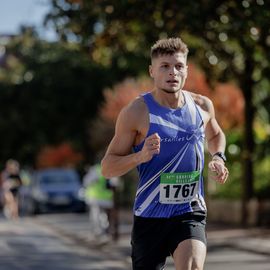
[{"xmin": 159, "ymin": 171, "xmax": 200, "ymax": 204}]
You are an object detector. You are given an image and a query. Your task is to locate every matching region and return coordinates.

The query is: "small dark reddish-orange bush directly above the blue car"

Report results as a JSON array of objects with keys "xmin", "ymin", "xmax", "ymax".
[{"xmin": 36, "ymin": 143, "xmax": 82, "ymax": 169}]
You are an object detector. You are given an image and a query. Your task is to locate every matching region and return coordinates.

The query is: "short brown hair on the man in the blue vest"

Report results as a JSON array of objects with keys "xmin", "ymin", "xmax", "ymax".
[{"xmin": 151, "ymin": 38, "xmax": 188, "ymax": 59}]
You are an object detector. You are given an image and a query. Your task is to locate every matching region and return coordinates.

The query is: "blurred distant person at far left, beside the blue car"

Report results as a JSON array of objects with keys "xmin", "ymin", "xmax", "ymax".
[{"xmin": 1, "ymin": 159, "xmax": 22, "ymax": 219}]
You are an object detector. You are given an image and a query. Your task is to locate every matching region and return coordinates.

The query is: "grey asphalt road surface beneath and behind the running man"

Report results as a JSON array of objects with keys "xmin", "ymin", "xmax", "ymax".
[{"xmin": 0, "ymin": 214, "xmax": 270, "ymax": 270}]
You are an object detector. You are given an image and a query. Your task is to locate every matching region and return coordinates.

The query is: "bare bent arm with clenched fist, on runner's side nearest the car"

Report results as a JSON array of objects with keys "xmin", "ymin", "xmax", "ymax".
[{"xmin": 101, "ymin": 100, "xmax": 160, "ymax": 178}]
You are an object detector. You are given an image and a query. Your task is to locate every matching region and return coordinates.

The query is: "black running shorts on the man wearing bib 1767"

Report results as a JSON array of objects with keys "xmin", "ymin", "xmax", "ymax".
[{"xmin": 131, "ymin": 212, "xmax": 206, "ymax": 270}]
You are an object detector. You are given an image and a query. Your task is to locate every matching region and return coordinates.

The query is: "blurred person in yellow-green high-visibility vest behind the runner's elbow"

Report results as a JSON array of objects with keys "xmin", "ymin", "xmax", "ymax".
[{"xmin": 83, "ymin": 164, "xmax": 119, "ymax": 240}]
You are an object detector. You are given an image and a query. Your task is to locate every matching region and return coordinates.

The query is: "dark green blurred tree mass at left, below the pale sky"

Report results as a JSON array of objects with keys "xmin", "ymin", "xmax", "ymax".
[{"xmin": 0, "ymin": 29, "xmax": 112, "ymax": 164}]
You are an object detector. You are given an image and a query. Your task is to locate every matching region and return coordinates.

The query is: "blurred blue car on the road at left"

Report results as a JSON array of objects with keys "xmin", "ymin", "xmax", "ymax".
[{"xmin": 21, "ymin": 168, "xmax": 85, "ymax": 214}]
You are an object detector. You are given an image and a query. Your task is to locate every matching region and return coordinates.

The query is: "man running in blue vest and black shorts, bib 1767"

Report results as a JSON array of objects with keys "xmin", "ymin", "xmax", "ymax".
[{"xmin": 102, "ymin": 38, "xmax": 228, "ymax": 270}]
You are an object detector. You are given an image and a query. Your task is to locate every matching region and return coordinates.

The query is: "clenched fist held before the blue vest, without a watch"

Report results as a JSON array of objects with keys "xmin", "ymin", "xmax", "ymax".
[{"xmin": 141, "ymin": 133, "xmax": 160, "ymax": 163}]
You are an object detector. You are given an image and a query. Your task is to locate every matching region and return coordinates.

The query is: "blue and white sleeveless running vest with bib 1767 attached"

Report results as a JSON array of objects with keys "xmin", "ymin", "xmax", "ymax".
[{"xmin": 133, "ymin": 91, "xmax": 206, "ymax": 218}]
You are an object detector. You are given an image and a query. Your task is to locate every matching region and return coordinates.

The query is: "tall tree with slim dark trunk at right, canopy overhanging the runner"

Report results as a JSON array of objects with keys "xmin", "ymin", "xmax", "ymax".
[{"xmin": 48, "ymin": 0, "xmax": 270, "ymax": 223}]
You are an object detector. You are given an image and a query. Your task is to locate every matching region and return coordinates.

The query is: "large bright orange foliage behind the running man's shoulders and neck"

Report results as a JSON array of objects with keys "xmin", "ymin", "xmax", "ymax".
[{"xmin": 101, "ymin": 63, "xmax": 244, "ymax": 129}]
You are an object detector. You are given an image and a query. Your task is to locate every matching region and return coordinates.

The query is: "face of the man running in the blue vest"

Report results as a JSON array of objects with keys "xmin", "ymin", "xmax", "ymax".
[{"xmin": 149, "ymin": 52, "xmax": 187, "ymax": 93}]
